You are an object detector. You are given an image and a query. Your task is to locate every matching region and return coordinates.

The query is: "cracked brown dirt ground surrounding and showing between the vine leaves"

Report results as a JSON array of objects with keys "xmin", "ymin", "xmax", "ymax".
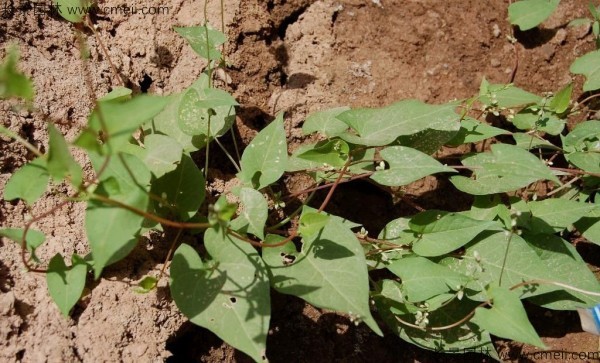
[{"xmin": 0, "ymin": 0, "xmax": 600, "ymax": 362}]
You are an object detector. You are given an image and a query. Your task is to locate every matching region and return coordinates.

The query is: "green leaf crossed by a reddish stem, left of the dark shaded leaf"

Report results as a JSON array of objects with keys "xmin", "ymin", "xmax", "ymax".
[{"xmin": 85, "ymin": 153, "xmax": 150, "ymax": 278}]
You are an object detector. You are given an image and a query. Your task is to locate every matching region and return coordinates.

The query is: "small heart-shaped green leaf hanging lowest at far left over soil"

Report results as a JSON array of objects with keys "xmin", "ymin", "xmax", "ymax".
[{"xmin": 46, "ymin": 253, "xmax": 87, "ymax": 316}]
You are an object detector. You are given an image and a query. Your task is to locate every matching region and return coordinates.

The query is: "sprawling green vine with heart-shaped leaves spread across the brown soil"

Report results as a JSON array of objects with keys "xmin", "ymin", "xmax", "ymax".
[{"xmin": 0, "ymin": 1, "xmax": 600, "ymax": 361}]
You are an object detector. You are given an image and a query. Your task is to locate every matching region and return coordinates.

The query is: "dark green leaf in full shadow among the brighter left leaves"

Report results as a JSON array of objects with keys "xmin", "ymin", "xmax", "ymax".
[{"xmin": 152, "ymin": 154, "xmax": 205, "ymax": 221}]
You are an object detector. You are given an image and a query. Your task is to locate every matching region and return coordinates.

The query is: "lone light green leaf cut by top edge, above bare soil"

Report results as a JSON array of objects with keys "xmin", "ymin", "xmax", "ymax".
[{"xmin": 508, "ymin": 0, "xmax": 560, "ymax": 31}]
